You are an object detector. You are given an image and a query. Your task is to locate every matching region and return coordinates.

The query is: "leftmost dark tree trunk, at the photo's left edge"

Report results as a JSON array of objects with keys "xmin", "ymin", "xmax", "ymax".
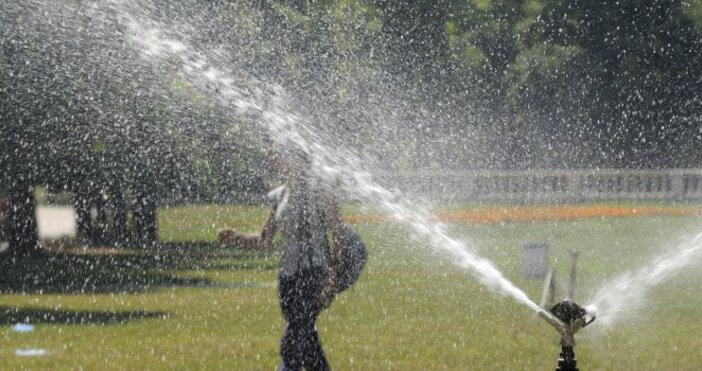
[{"xmin": 8, "ymin": 184, "xmax": 40, "ymax": 257}]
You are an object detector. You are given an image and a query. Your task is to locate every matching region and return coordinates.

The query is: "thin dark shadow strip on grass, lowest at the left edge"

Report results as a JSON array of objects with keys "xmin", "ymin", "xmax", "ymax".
[{"xmin": 0, "ymin": 306, "xmax": 168, "ymax": 326}]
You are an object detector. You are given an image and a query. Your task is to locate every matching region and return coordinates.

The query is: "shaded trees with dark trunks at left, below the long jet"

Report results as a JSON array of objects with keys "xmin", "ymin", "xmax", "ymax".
[{"xmin": 0, "ymin": 1, "xmax": 270, "ymax": 253}]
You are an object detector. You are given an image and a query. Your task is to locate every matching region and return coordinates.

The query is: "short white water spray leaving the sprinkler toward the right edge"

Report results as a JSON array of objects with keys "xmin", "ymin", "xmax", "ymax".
[{"xmin": 589, "ymin": 233, "xmax": 702, "ymax": 327}]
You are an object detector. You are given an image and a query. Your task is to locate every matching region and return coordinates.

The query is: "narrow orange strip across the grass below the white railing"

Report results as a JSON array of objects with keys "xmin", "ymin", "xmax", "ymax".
[{"xmin": 345, "ymin": 205, "xmax": 702, "ymax": 224}]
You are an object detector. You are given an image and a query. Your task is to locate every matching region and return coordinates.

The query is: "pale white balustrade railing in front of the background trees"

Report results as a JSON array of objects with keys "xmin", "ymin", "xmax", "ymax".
[{"xmin": 389, "ymin": 169, "xmax": 702, "ymax": 202}]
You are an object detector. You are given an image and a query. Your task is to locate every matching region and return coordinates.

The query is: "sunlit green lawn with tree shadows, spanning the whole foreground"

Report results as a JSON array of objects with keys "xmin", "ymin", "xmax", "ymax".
[{"xmin": 0, "ymin": 206, "xmax": 702, "ymax": 370}]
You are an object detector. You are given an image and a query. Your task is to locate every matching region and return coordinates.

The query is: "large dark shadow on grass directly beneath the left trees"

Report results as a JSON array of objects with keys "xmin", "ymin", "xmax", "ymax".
[{"xmin": 0, "ymin": 243, "xmax": 275, "ymax": 294}]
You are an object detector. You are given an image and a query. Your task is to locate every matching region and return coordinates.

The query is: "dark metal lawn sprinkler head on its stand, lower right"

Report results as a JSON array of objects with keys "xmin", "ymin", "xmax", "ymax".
[{"xmin": 539, "ymin": 299, "xmax": 596, "ymax": 371}]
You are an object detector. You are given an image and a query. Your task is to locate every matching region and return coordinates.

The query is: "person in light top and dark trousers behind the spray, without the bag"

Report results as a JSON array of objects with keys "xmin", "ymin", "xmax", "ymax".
[{"xmin": 218, "ymin": 151, "xmax": 338, "ymax": 371}]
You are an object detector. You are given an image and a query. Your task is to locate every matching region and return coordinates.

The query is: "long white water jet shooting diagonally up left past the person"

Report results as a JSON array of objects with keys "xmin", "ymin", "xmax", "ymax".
[{"xmin": 115, "ymin": 4, "xmax": 540, "ymax": 311}]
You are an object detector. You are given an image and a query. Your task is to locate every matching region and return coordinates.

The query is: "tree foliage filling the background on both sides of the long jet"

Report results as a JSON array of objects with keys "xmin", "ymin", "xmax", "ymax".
[{"xmin": 0, "ymin": 0, "xmax": 702, "ymax": 197}]
